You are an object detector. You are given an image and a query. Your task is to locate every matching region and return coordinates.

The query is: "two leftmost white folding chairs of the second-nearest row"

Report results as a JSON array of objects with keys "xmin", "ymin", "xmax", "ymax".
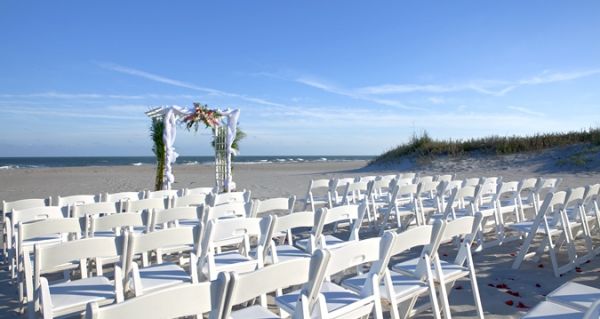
[{"xmin": 24, "ymin": 227, "xmax": 198, "ymax": 318}]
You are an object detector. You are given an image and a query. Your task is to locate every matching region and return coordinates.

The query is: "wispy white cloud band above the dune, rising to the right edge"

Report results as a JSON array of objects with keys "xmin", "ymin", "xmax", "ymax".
[{"xmin": 352, "ymin": 69, "xmax": 600, "ymax": 96}]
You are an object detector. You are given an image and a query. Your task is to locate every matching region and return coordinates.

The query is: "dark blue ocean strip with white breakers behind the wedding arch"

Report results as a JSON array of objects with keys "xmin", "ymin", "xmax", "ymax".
[{"xmin": 0, "ymin": 155, "xmax": 374, "ymax": 169}]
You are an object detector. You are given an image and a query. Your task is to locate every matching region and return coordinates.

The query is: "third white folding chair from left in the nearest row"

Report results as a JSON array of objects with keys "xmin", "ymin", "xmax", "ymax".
[{"xmin": 275, "ymin": 238, "xmax": 383, "ymax": 318}]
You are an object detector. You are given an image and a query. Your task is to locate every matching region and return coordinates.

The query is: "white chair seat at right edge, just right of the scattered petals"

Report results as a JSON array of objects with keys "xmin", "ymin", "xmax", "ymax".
[{"xmin": 546, "ymin": 281, "xmax": 600, "ymax": 311}]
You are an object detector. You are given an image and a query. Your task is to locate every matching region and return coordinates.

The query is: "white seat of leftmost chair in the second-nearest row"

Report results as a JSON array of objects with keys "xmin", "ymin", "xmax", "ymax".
[{"xmin": 49, "ymin": 276, "xmax": 115, "ymax": 315}]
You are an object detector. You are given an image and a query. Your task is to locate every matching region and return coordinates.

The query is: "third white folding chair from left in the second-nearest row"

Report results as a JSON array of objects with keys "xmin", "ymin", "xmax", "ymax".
[{"xmin": 196, "ymin": 216, "xmax": 272, "ymax": 280}]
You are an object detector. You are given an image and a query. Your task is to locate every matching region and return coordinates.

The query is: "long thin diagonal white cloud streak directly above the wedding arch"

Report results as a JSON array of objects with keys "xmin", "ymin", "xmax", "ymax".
[{"xmin": 98, "ymin": 63, "xmax": 288, "ymax": 108}]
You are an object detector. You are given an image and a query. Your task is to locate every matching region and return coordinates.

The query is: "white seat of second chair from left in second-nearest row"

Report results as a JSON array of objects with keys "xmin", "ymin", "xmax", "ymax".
[{"xmin": 140, "ymin": 263, "xmax": 192, "ymax": 293}]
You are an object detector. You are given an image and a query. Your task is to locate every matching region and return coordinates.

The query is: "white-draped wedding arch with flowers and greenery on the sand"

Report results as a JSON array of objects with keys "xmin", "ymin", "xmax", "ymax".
[{"xmin": 146, "ymin": 103, "xmax": 240, "ymax": 192}]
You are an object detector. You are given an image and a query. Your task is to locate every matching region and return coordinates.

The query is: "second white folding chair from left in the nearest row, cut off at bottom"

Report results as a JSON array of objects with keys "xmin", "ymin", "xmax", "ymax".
[{"xmin": 223, "ymin": 258, "xmax": 310, "ymax": 319}]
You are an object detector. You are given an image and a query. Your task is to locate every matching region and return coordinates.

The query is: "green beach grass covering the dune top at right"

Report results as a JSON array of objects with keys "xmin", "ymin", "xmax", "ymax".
[{"xmin": 370, "ymin": 128, "xmax": 600, "ymax": 164}]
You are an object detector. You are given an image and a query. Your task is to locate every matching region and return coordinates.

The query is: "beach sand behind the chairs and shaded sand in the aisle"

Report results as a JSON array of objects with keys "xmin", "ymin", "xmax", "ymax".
[{"xmin": 0, "ymin": 157, "xmax": 600, "ymax": 318}]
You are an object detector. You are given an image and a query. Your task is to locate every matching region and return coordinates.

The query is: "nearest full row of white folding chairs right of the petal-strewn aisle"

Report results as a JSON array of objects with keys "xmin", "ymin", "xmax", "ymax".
[{"xmin": 509, "ymin": 185, "xmax": 600, "ymax": 277}]
